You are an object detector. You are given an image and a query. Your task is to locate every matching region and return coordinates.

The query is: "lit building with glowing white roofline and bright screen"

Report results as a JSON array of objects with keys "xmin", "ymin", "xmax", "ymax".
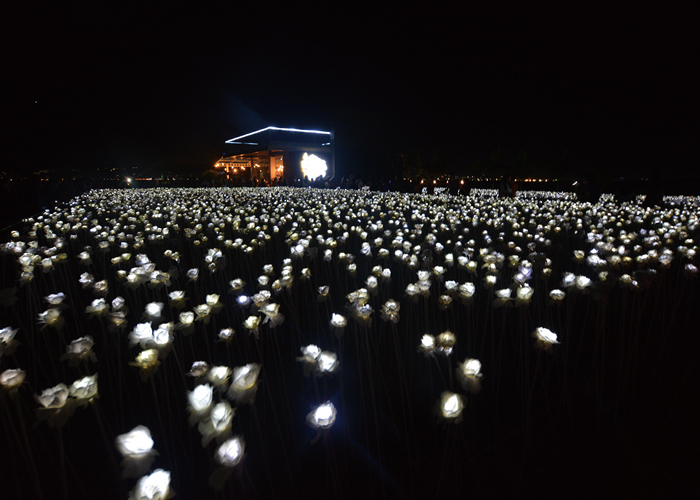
[{"xmin": 215, "ymin": 127, "xmax": 335, "ymax": 182}]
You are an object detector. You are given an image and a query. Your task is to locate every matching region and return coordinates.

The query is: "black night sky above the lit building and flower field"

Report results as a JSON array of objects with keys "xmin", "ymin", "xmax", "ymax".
[{"xmin": 2, "ymin": 1, "xmax": 698, "ymax": 180}]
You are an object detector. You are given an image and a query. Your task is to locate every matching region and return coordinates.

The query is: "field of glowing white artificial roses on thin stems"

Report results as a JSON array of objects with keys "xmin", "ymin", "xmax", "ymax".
[{"xmin": 0, "ymin": 188, "xmax": 700, "ymax": 500}]
